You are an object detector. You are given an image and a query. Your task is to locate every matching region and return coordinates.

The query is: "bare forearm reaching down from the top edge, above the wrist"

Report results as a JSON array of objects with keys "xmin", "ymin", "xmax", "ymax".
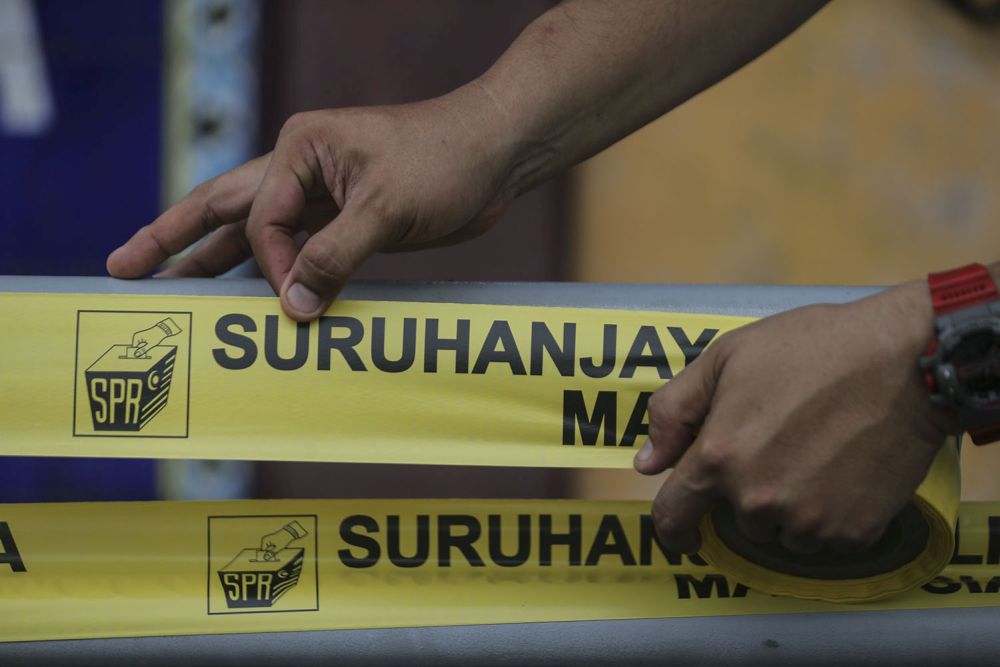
[{"xmin": 473, "ymin": 0, "xmax": 826, "ymax": 195}]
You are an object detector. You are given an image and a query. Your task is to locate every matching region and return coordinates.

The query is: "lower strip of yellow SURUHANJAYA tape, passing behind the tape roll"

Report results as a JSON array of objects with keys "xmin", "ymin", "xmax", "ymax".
[{"xmin": 0, "ymin": 500, "xmax": 1000, "ymax": 641}]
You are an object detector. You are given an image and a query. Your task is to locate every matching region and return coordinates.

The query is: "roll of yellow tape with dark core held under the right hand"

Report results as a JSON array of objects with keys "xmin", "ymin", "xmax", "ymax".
[{"xmin": 700, "ymin": 438, "xmax": 961, "ymax": 602}]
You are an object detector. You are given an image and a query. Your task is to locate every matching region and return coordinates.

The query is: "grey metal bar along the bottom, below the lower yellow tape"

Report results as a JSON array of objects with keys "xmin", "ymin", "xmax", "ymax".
[{"xmin": 0, "ymin": 609, "xmax": 1000, "ymax": 667}]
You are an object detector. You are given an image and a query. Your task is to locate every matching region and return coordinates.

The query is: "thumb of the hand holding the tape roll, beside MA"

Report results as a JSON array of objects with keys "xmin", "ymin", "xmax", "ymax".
[{"xmin": 633, "ymin": 346, "xmax": 721, "ymax": 475}]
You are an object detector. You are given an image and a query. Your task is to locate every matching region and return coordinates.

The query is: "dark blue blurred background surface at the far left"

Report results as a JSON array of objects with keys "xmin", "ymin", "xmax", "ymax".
[{"xmin": 0, "ymin": 0, "xmax": 163, "ymax": 502}]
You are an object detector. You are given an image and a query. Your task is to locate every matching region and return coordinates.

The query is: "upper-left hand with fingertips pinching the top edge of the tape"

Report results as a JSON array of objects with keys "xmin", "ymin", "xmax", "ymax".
[{"xmin": 107, "ymin": 83, "xmax": 515, "ymax": 321}]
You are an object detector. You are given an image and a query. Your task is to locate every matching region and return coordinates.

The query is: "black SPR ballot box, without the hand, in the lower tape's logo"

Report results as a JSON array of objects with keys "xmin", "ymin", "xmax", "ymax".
[{"xmin": 219, "ymin": 548, "xmax": 305, "ymax": 609}]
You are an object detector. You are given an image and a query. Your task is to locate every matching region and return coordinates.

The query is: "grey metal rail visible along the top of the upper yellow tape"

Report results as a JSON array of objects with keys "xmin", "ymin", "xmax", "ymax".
[{"xmin": 0, "ymin": 276, "xmax": 877, "ymax": 317}]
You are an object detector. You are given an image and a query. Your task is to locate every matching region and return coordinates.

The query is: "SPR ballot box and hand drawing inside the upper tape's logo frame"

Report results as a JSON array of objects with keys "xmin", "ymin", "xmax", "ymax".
[{"xmin": 85, "ymin": 317, "xmax": 181, "ymax": 431}]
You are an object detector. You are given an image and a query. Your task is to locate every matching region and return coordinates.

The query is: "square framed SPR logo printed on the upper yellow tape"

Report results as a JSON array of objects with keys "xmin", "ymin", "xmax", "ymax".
[{"xmin": 73, "ymin": 311, "xmax": 191, "ymax": 438}]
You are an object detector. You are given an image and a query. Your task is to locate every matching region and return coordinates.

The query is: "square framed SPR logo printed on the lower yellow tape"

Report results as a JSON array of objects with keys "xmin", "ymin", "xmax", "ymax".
[{"xmin": 208, "ymin": 515, "xmax": 319, "ymax": 614}]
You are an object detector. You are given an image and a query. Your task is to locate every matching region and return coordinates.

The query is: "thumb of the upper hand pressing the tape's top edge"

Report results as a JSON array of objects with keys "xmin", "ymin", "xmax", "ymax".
[{"xmin": 281, "ymin": 205, "xmax": 388, "ymax": 322}]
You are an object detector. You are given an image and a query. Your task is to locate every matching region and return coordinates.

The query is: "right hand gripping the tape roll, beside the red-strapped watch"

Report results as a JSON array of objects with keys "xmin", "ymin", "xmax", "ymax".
[{"xmin": 635, "ymin": 281, "xmax": 957, "ymax": 553}]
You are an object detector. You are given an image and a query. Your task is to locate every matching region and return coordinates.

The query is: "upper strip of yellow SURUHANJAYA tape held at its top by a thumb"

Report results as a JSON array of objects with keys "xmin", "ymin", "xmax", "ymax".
[{"xmin": 0, "ymin": 293, "xmax": 751, "ymax": 468}]
